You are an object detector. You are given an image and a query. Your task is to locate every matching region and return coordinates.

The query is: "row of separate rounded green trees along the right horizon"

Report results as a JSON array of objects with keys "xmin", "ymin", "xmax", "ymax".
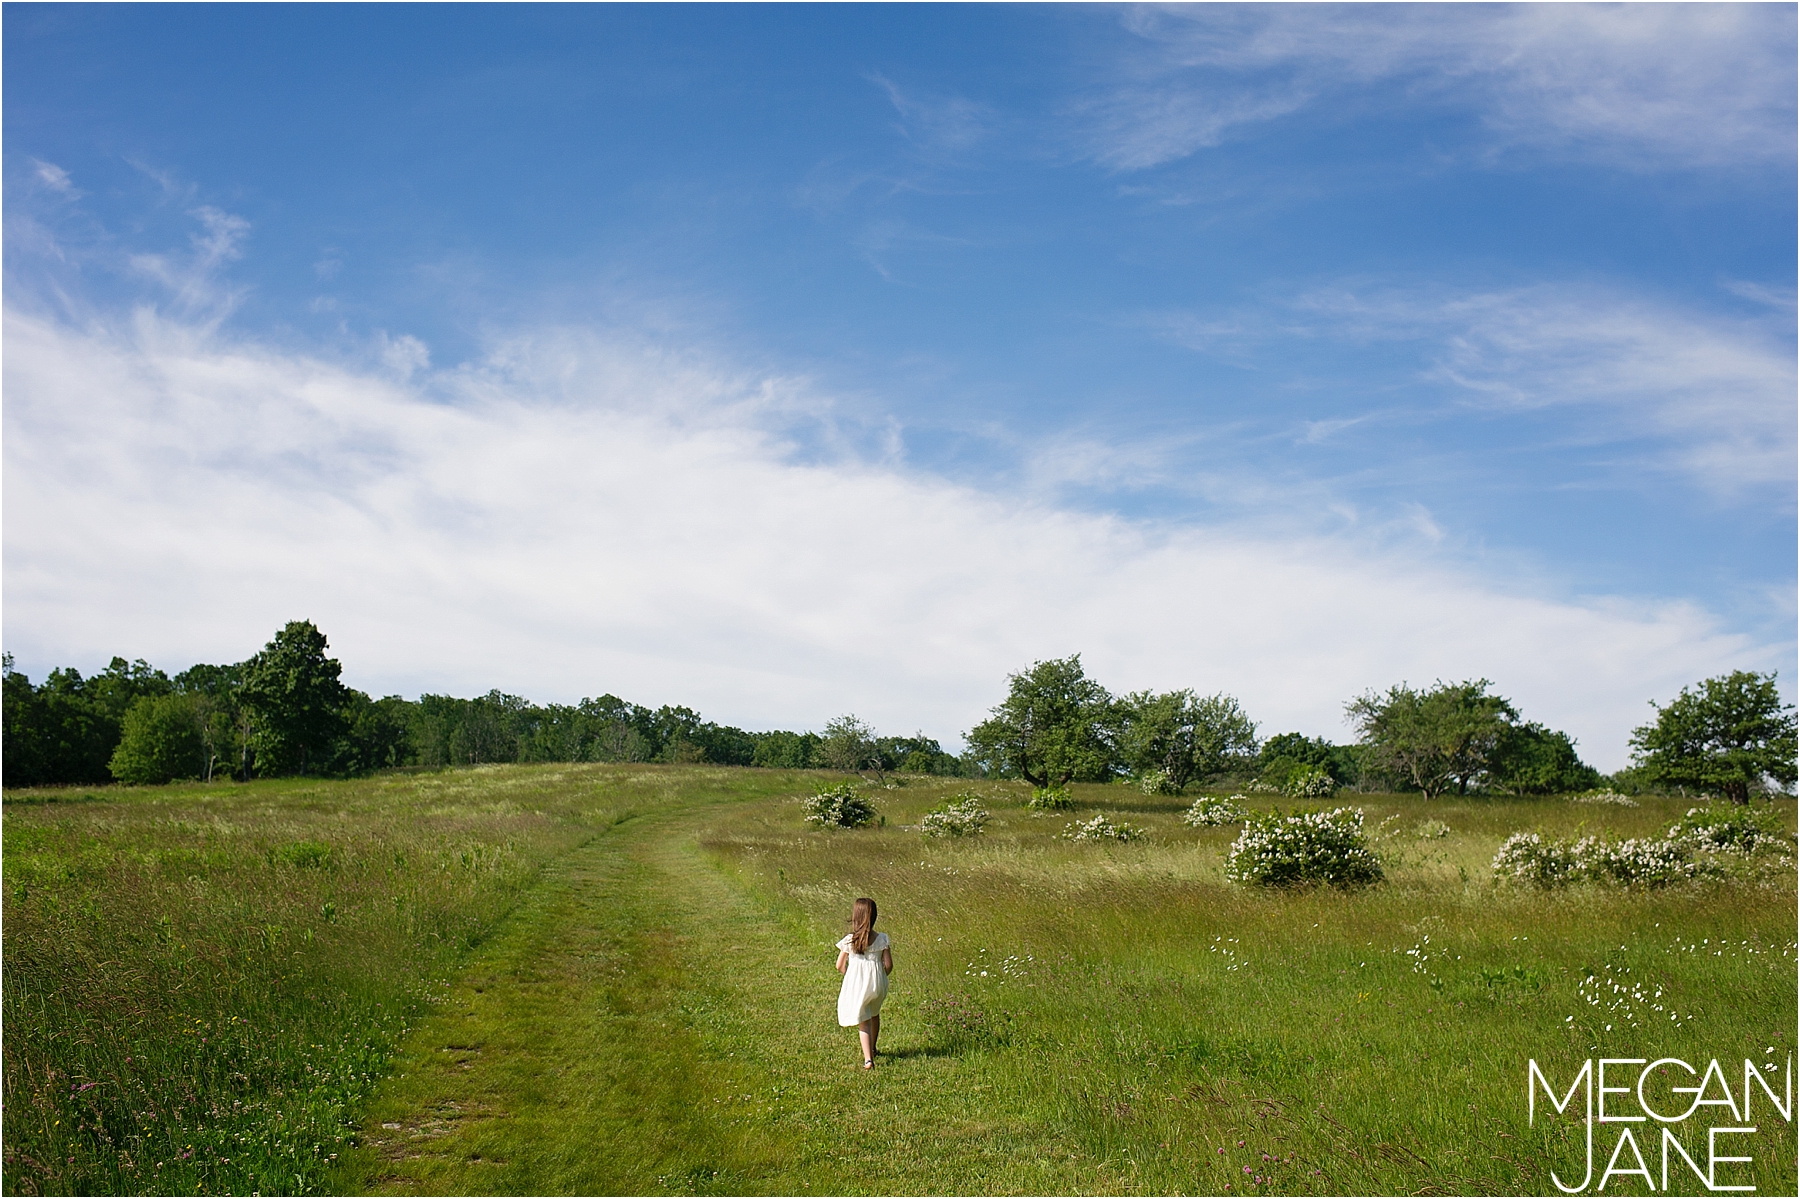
[{"xmin": 967, "ymin": 654, "xmax": 1795, "ymax": 803}]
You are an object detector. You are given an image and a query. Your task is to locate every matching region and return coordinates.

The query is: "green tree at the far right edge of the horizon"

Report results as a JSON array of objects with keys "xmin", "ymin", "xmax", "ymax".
[{"xmin": 1631, "ymin": 670, "xmax": 1795, "ymax": 803}]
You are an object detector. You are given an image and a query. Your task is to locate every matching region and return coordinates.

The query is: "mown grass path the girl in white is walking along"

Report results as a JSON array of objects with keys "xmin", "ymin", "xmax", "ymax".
[{"xmin": 338, "ymin": 784, "xmax": 1121, "ymax": 1194}]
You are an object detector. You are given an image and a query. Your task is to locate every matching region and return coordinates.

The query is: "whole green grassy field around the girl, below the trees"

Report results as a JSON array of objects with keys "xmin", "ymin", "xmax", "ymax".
[{"xmin": 0, "ymin": 765, "xmax": 1796, "ymax": 1194}]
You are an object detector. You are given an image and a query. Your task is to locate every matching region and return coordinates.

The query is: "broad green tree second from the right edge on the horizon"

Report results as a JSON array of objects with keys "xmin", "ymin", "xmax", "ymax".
[{"xmin": 1345, "ymin": 679, "xmax": 1517, "ymax": 799}]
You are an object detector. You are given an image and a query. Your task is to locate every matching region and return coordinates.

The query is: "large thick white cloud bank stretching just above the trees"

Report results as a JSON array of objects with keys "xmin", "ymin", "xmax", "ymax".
[{"xmin": 4, "ymin": 311, "xmax": 1789, "ymax": 767}]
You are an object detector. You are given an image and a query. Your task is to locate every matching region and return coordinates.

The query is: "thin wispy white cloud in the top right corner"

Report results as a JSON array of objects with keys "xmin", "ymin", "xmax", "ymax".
[{"xmin": 1094, "ymin": 4, "xmax": 1795, "ymax": 171}]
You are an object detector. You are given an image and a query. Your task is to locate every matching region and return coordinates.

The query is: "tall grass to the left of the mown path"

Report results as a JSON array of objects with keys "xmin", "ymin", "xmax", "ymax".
[{"xmin": 4, "ymin": 767, "xmax": 709, "ymax": 1194}]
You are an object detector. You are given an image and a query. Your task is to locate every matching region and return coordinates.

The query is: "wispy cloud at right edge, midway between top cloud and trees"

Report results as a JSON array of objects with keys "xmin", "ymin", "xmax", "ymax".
[{"xmin": 1143, "ymin": 281, "xmax": 1796, "ymax": 493}]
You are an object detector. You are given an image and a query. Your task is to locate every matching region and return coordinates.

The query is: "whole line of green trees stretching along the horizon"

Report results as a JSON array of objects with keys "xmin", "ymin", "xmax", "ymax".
[{"xmin": 4, "ymin": 621, "xmax": 1795, "ymax": 801}]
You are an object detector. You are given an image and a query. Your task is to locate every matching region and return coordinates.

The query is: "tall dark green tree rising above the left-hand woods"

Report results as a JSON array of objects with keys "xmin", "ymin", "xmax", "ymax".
[{"xmin": 238, "ymin": 621, "xmax": 347, "ymax": 774}]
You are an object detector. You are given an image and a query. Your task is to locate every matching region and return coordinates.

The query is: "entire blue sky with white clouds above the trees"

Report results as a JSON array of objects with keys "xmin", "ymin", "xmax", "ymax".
[{"xmin": 4, "ymin": 4, "xmax": 1796, "ymax": 767}]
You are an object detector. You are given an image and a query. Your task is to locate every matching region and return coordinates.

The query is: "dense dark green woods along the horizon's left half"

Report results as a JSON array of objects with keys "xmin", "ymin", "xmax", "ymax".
[{"xmin": 4, "ymin": 621, "xmax": 963, "ymax": 787}]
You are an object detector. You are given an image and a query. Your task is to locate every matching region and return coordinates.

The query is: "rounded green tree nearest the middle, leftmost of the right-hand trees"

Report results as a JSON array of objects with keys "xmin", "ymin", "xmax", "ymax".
[{"xmin": 968, "ymin": 654, "xmax": 1118, "ymax": 787}]
